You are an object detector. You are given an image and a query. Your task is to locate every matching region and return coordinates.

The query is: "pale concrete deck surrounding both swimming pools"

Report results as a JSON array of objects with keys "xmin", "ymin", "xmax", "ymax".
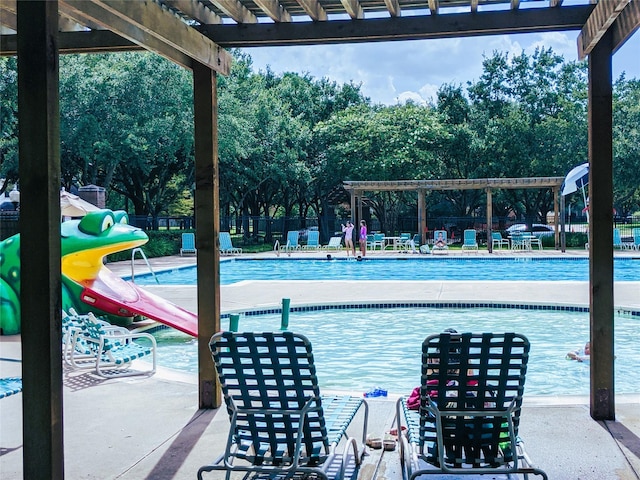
[{"xmin": 0, "ymin": 251, "xmax": 640, "ymax": 480}]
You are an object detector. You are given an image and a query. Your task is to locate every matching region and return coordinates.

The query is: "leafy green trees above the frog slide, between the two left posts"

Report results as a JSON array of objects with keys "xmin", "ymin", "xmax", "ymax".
[{"xmin": 60, "ymin": 53, "xmax": 193, "ymax": 218}]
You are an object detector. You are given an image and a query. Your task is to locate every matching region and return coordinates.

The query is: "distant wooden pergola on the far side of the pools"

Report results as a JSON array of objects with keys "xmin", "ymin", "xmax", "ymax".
[{"xmin": 342, "ymin": 177, "xmax": 564, "ymax": 253}]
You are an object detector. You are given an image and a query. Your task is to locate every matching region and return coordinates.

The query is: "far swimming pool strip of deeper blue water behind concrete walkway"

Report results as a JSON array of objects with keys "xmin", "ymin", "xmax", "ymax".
[{"xmin": 135, "ymin": 257, "xmax": 640, "ymax": 285}]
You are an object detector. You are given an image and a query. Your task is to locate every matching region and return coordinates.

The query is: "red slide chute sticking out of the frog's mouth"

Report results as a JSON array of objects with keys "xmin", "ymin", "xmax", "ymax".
[{"xmin": 80, "ymin": 268, "xmax": 198, "ymax": 337}]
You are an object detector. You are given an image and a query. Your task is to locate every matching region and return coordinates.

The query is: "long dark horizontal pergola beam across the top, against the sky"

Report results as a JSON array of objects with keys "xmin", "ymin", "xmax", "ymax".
[{"xmin": 200, "ymin": 5, "xmax": 594, "ymax": 48}]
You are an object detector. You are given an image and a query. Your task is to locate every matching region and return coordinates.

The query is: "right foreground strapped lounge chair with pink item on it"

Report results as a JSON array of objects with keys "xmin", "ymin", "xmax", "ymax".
[{"xmin": 396, "ymin": 333, "xmax": 547, "ymax": 480}]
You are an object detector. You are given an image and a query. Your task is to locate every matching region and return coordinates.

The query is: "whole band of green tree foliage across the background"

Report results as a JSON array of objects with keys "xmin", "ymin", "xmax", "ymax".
[{"xmin": 0, "ymin": 49, "xmax": 640, "ymax": 232}]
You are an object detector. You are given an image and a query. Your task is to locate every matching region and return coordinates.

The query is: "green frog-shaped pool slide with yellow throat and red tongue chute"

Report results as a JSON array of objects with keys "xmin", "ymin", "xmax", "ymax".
[{"xmin": 0, "ymin": 209, "xmax": 198, "ymax": 336}]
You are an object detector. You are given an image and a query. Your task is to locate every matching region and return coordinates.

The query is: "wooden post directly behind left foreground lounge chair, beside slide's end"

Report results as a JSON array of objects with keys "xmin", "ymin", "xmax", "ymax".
[{"xmin": 193, "ymin": 62, "xmax": 221, "ymax": 408}]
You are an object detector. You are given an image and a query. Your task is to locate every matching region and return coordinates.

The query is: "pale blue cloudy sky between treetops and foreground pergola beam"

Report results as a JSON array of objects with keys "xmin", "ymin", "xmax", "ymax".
[{"xmin": 245, "ymin": 31, "xmax": 640, "ymax": 105}]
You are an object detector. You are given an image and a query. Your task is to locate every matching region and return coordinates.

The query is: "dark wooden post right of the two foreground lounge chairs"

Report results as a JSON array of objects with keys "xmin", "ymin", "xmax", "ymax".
[{"xmin": 588, "ymin": 31, "xmax": 615, "ymax": 420}]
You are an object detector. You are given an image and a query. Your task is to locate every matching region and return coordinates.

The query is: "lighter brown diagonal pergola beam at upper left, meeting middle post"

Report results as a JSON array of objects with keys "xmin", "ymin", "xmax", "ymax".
[{"xmin": 60, "ymin": 0, "xmax": 231, "ymax": 75}]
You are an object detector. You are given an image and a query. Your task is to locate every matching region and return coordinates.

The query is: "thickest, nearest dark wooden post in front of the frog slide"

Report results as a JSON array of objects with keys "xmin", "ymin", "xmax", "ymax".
[{"xmin": 17, "ymin": 1, "xmax": 64, "ymax": 480}]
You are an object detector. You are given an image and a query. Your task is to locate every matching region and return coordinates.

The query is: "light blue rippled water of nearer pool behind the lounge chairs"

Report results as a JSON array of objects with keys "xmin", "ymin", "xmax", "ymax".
[{"xmin": 154, "ymin": 308, "xmax": 640, "ymax": 395}]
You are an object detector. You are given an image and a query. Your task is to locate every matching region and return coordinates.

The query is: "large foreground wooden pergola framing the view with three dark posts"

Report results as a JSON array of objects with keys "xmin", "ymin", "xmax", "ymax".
[{"xmin": 0, "ymin": 0, "xmax": 640, "ymax": 479}]
